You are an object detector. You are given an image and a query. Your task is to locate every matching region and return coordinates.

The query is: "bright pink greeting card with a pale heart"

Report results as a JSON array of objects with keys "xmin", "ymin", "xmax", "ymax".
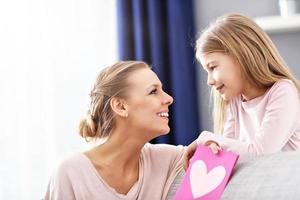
[{"xmin": 175, "ymin": 145, "xmax": 239, "ymax": 200}]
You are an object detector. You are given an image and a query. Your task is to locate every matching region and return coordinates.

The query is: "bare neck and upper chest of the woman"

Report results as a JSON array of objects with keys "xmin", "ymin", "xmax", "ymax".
[{"xmin": 85, "ymin": 130, "xmax": 145, "ymax": 194}]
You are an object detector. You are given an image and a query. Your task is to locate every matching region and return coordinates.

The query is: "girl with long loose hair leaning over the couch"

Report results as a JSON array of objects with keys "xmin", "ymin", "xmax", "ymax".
[{"xmin": 185, "ymin": 14, "xmax": 300, "ymax": 165}]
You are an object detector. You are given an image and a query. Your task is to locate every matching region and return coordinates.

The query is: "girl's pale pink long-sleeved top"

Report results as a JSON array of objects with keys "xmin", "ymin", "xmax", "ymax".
[{"xmin": 197, "ymin": 79, "xmax": 300, "ymax": 156}]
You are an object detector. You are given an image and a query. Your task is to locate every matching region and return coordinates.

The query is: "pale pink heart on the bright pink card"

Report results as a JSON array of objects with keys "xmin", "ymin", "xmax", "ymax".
[{"xmin": 190, "ymin": 160, "xmax": 226, "ymax": 198}]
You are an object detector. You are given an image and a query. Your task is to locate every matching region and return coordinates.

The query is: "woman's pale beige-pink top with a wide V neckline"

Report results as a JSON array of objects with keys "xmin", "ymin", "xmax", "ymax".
[{"xmin": 45, "ymin": 143, "xmax": 184, "ymax": 200}]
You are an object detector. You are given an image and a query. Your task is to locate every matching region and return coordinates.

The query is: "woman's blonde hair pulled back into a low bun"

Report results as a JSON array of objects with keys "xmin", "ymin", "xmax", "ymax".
[{"xmin": 79, "ymin": 61, "xmax": 150, "ymax": 141}]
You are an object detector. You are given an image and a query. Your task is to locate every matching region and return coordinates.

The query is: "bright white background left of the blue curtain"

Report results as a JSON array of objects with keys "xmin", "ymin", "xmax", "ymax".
[{"xmin": 0, "ymin": 0, "xmax": 117, "ymax": 200}]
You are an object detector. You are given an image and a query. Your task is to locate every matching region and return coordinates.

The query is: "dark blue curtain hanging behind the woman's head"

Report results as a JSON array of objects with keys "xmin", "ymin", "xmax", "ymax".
[{"xmin": 117, "ymin": 0, "xmax": 199, "ymax": 145}]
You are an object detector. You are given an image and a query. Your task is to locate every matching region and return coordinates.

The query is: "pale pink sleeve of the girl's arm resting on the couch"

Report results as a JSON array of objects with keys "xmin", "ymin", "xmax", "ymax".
[{"xmin": 197, "ymin": 82, "xmax": 300, "ymax": 156}]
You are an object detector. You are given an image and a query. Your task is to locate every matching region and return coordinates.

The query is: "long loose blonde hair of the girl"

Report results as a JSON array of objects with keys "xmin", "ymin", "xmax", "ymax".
[{"xmin": 196, "ymin": 13, "xmax": 300, "ymax": 134}]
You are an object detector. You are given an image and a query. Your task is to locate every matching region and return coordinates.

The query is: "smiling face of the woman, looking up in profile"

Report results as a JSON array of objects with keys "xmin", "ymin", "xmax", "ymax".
[{"xmin": 126, "ymin": 68, "xmax": 173, "ymax": 139}]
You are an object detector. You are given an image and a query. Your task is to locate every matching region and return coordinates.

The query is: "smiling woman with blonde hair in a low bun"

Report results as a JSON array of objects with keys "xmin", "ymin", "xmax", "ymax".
[{"xmin": 45, "ymin": 61, "xmax": 184, "ymax": 200}]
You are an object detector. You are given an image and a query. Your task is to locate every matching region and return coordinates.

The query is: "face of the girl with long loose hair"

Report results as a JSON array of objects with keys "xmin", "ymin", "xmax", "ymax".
[{"xmin": 200, "ymin": 52, "xmax": 246, "ymax": 100}]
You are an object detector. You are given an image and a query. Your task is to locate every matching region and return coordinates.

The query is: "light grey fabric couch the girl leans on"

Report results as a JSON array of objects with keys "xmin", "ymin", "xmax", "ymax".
[{"xmin": 167, "ymin": 150, "xmax": 300, "ymax": 200}]
